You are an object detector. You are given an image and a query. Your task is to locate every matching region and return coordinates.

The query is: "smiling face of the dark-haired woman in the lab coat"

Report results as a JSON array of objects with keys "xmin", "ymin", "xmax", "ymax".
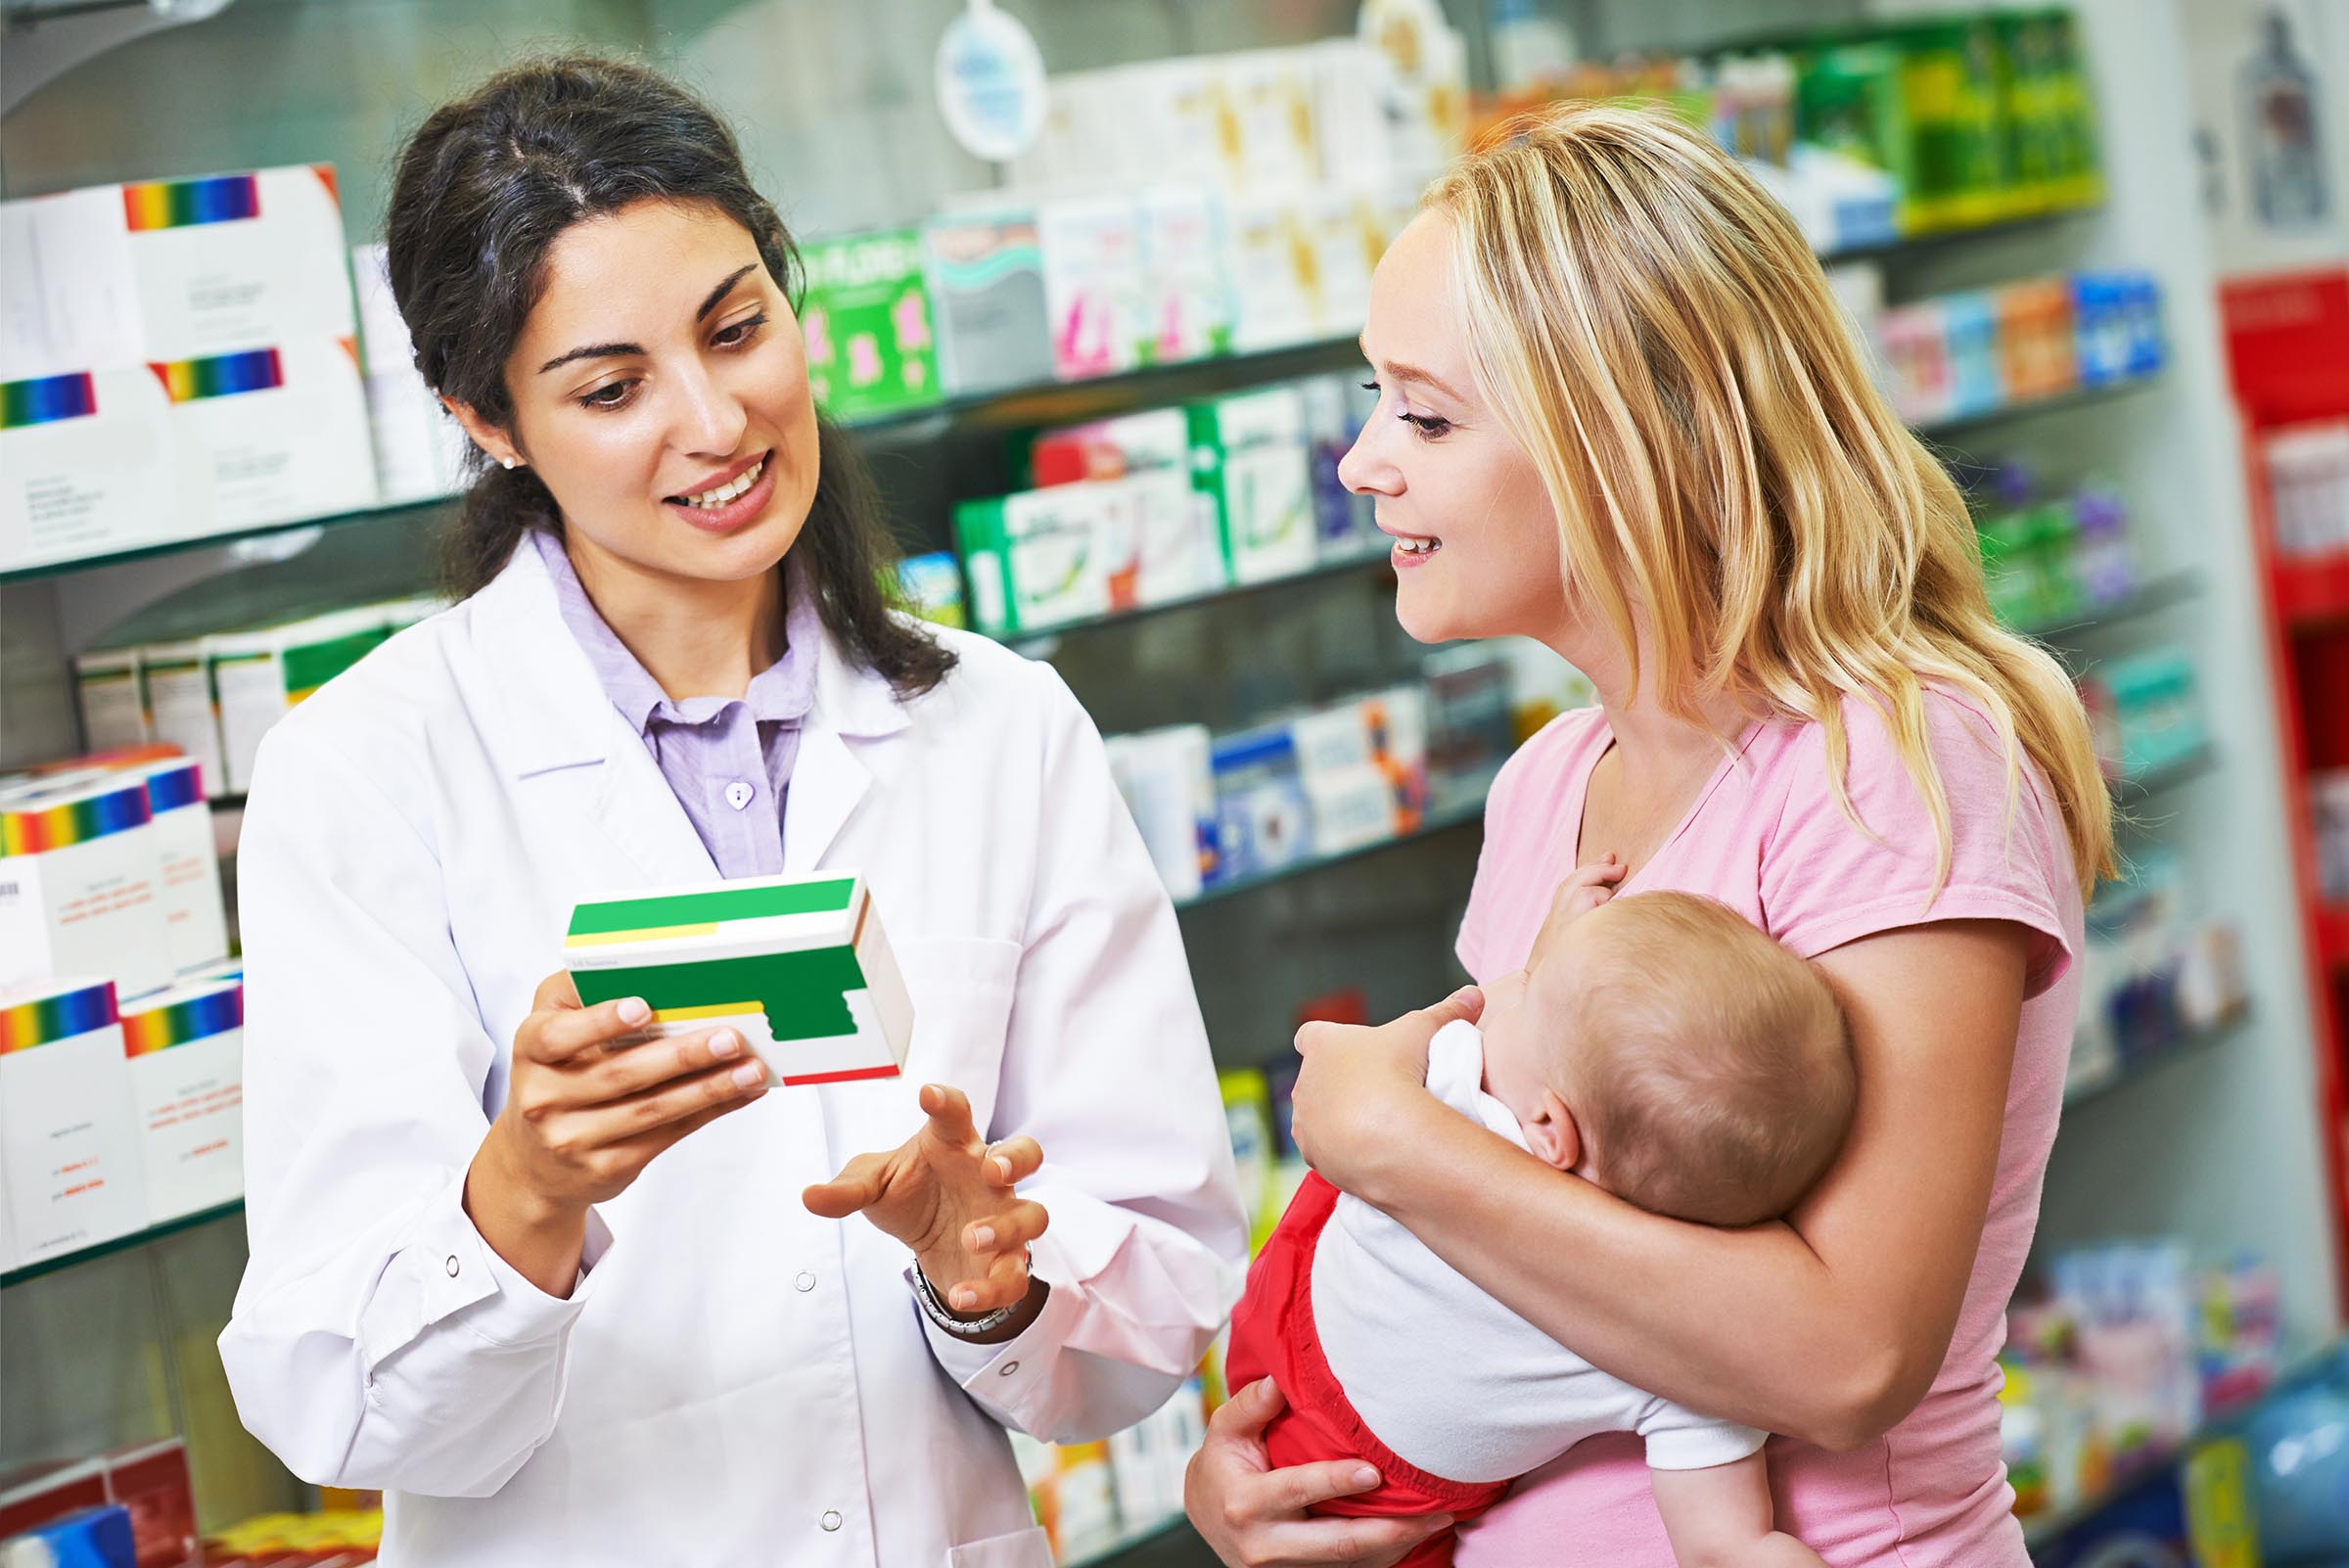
[{"xmin": 505, "ymin": 202, "xmax": 817, "ymax": 582}]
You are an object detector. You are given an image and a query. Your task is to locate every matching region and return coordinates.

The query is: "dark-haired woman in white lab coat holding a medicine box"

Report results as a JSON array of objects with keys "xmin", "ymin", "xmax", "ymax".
[{"xmin": 221, "ymin": 59, "xmax": 1245, "ymax": 1568}]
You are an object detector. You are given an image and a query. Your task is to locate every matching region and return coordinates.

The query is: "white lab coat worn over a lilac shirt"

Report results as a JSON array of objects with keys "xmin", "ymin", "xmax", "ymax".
[{"xmin": 221, "ymin": 532, "xmax": 1245, "ymax": 1568}]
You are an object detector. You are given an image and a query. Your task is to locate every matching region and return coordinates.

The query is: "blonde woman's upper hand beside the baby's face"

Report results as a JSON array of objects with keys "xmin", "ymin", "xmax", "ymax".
[{"xmin": 1290, "ymin": 986, "xmax": 1485, "ymax": 1204}]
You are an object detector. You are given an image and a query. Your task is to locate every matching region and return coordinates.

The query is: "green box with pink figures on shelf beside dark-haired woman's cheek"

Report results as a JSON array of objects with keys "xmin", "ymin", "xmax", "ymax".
[{"xmin": 799, "ymin": 228, "xmax": 942, "ymax": 420}]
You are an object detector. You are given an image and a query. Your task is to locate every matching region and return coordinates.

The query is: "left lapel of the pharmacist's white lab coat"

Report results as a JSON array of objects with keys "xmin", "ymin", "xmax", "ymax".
[{"xmin": 470, "ymin": 542, "xmax": 718, "ymax": 885}]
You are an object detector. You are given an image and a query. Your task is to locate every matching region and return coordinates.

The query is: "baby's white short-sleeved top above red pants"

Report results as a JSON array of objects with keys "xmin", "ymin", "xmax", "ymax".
[{"xmin": 1313, "ymin": 1024, "xmax": 1767, "ymax": 1481}]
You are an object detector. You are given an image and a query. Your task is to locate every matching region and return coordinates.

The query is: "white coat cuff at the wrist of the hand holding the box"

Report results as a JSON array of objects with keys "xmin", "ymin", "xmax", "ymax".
[{"xmin": 359, "ymin": 1172, "xmax": 611, "ymax": 1371}]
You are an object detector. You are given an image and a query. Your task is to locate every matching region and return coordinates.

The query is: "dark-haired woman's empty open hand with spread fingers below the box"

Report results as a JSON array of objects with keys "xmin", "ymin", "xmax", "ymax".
[{"xmin": 801, "ymin": 1084, "xmax": 1050, "ymax": 1314}]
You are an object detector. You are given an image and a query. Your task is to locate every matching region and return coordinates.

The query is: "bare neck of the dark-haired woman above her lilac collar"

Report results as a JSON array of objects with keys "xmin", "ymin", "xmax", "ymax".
[{"xmin": 564, "ymin": 535, "xmax": 785, "ymax": 702}]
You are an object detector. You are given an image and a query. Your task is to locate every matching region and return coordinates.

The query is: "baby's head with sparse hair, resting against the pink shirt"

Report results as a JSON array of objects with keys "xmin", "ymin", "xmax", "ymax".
[{"xmin": 1485, "ymin": 892, "xmax": 1856, "ymax": 1225}]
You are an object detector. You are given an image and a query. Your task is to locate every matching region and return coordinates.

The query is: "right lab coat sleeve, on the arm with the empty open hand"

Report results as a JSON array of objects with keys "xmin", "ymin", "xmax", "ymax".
[{"xmin": 916, "ymin": 665, "xmax": 1247, "ymax": 1441}]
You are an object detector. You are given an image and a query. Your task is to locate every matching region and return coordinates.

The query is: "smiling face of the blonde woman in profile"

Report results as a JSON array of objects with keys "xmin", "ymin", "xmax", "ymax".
[{"xmin": 1339, "ymin": 211, "xmax": 1564, "ymax": 643}]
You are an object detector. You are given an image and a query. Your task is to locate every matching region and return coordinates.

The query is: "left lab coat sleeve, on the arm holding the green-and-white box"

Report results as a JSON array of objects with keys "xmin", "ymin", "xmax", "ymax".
[{"xmin": 221, "ymin": 712, "xmax": 609, "ymax": 1498}]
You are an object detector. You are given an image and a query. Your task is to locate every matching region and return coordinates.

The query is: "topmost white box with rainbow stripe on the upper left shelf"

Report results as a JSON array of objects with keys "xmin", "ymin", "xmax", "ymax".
[{"xmin": 0, "ymin": 164, "xmax": 357, "ymax": 373}]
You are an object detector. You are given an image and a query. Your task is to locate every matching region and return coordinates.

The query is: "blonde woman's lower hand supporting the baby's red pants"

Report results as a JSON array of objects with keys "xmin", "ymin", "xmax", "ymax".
[{"xmin": 1181, "ymin": 1378, "xmax": 1451, "ymax": 1568}]
